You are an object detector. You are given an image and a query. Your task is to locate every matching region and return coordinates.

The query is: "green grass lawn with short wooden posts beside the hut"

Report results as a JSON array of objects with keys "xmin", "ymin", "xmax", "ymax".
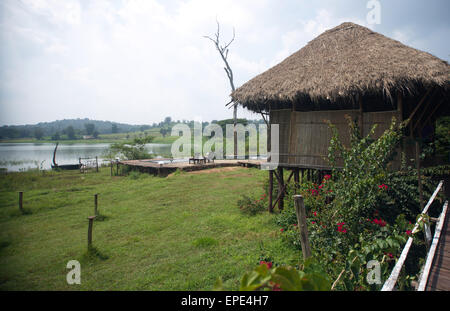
[{"xmin": 0, "ymin": 168, "xmax": 300, "ymax": 290}]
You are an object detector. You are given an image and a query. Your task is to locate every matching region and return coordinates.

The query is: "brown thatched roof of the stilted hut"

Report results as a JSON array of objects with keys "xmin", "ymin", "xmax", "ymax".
[{"xmin": 231, "ymin": 23, "xmax": 450, "ymax": 111}]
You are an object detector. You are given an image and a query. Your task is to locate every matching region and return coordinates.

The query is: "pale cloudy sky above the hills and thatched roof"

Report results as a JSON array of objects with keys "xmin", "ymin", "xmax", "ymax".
[{"xmin": 0, "ymin": 0, "xmax": 450, "ymax": 126}]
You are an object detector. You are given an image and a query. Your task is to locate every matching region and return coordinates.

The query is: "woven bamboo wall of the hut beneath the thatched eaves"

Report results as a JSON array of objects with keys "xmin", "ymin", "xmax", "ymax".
[{"xmin": 270, "ymin": 110, "xmax": 400, "ymax": 169}]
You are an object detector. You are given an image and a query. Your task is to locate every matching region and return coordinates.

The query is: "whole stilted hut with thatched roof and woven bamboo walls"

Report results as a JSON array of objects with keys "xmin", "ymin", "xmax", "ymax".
[{"xmin": 231, "ymin": 23, "xmax": 450, "ymax": 210}]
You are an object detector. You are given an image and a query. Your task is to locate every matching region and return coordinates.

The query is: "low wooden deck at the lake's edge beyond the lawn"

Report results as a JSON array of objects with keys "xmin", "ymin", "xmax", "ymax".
[{"xmin": 117, "ymin": 159, "xmax": 265, "ymax": 176}]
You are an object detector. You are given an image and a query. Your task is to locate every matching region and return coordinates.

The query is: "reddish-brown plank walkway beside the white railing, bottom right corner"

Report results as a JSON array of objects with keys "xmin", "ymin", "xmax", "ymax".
[{"xmin": 426, "ymin": 204, "xmax": 450, "ymax": 291}]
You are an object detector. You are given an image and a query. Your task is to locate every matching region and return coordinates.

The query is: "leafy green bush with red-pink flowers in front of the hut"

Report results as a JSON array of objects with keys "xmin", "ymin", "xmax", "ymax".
[{"xmin": 270, "ymin": 120, "xmax": 440, "ymax": 290}]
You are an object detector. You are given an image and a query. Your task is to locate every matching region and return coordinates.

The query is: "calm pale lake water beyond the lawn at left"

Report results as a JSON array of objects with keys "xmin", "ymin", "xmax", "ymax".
[{"xmin": 0, "ymin": 143, "xmax": 170, "ymax": 171}]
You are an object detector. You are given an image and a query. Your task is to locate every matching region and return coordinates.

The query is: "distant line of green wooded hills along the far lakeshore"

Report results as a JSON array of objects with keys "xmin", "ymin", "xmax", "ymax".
[{"xmin": 0, "ymin": 117, "xmax": 264, "ymax": 140}]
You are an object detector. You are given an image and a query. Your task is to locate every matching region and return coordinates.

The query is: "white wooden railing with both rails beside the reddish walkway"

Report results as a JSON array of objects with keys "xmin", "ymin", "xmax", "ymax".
[{"xmin": 381, "ymin": 180, "xmax": 448, "ymax": 291}]
